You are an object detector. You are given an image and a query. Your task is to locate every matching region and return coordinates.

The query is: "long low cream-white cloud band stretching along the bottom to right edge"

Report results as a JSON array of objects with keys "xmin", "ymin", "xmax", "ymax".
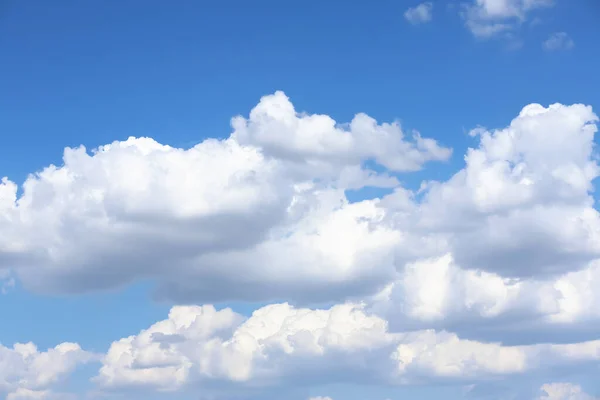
[{"xmin": 96, "ymin": 304, "xmax": 600, "ymax": 390}]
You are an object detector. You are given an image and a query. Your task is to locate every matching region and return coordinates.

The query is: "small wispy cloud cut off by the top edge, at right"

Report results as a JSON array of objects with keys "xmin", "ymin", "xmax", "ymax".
[{"xmin": 462, "ymin": 0, "xmax": 554, "ymax": 38}]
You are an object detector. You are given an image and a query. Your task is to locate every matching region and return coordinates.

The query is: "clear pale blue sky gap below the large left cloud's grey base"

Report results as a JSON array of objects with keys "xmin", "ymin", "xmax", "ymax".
[{"xmin": 0, "ymin": 283, "xmax": 170, "ymax": 352}]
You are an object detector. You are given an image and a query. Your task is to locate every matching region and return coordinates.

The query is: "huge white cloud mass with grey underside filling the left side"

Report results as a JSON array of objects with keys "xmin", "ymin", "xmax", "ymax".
[{"xmin": 0, "ymin": 92, "xmax": 450, "ymax": 300}]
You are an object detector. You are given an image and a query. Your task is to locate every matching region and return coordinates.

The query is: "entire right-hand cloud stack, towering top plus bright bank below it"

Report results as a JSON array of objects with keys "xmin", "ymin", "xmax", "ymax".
[{"xmin": 364, "ymin": 105, "xmax": 600, "ymax": 340}]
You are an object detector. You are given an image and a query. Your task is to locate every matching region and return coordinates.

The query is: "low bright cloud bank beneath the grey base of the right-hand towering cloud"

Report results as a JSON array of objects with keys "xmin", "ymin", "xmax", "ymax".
[{"xmin": 369, "ymin": 255, "xmax": 600, "ymax": 343}]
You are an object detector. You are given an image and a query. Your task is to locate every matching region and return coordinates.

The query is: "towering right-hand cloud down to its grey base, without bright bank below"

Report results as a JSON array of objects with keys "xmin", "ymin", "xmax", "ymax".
[{"xmin": 390, "ymin": 104, "xmax": 600, "ymax": 278}]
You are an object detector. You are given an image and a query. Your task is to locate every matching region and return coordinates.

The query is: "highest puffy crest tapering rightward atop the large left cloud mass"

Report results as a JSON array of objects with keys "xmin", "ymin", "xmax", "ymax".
[{"xmin": 231, "ymin": 92, "xmax": 451, "ymax": 173}]
